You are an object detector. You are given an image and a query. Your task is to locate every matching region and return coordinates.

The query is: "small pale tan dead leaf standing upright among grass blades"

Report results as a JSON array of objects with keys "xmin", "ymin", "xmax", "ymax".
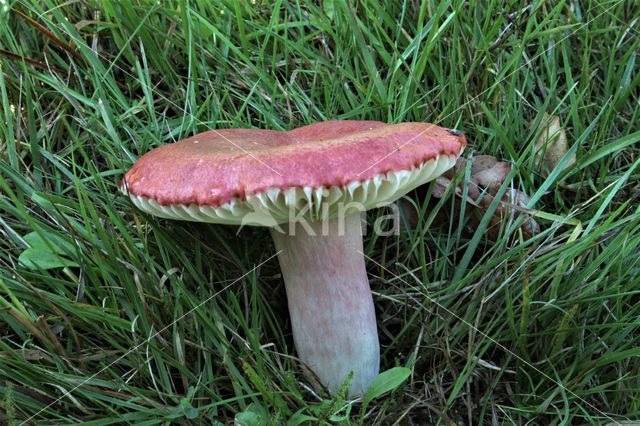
[{"xmin": 531, "ymin": 112, "xmax": 576, "ymax": 177}]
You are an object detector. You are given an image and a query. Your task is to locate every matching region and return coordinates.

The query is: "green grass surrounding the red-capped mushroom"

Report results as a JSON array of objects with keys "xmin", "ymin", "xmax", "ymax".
[{"xmin": 0, "ymin": 0, "xmax": 640, "ymax": 425}]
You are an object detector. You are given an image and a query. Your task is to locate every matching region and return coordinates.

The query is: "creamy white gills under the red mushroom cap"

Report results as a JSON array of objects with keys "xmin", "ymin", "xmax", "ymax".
[{"xmin": 129, "ymin": 155, "xmax": 457, "ymax": 226}]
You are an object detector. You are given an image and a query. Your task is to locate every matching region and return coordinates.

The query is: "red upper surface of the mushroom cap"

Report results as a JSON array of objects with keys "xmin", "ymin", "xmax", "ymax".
[{"xmin": 123, "ymin": 120, "xmax": 466, "ymax": 207}]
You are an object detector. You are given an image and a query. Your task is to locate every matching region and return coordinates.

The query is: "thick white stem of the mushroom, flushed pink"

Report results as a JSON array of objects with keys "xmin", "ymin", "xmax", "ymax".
[{"xmin": 271, "ymin": 213, "xmax": 380, "ymax": 397}]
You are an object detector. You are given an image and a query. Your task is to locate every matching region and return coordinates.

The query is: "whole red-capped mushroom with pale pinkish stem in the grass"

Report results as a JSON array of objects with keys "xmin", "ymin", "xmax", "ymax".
[{"xmin": 122, "ymin": 120, "xmax": 466, "ymax": 396}]
